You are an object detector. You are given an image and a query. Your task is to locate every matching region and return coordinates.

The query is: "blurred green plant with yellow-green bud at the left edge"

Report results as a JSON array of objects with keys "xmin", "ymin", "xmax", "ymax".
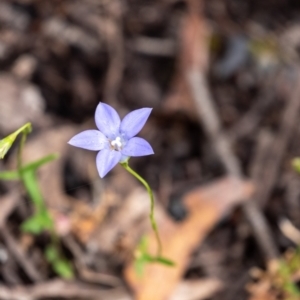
[{"xmin": 0, "ymin": 123, "xmax": 73, "ymax": 278}]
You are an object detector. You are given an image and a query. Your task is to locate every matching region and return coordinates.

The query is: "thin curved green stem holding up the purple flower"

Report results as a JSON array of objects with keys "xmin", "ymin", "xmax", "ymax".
[{"xmin": 121, "ymin": 161, "xmax": 162, "ymax": 257}]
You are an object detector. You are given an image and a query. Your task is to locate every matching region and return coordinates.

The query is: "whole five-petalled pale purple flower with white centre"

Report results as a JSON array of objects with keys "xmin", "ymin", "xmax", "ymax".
[{"xmin": 68, "ymin": 102, "xmax": 154, "ymax": 178}]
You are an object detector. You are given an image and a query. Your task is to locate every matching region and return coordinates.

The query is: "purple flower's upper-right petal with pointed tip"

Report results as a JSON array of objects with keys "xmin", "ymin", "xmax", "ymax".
[{"xmin": 120, "ymin": 107, "xmax": 152, "ymax": 139}]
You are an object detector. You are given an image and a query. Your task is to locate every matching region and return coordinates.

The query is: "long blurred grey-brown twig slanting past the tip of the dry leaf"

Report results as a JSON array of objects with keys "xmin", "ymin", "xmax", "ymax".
[{"xmin": 186, "ymin": 68, "xmax": 278, "ymax": 260}]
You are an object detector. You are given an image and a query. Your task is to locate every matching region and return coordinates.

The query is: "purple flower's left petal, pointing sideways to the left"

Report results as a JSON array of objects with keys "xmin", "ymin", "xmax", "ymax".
[{"xmin": 68, "ymin": 130, "xmax": 109, "ymax": 151}]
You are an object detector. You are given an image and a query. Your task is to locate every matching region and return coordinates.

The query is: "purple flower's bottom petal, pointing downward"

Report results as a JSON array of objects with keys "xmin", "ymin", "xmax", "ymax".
[{"xmin": 96, "ymin": 149, "xmax": 121, "ymax": 178}]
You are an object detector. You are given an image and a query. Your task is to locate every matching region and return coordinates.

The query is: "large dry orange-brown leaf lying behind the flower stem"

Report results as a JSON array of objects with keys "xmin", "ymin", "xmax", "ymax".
[{"xmin": 125, "ymin": 177, "xmax": 253, "ymax": 300}]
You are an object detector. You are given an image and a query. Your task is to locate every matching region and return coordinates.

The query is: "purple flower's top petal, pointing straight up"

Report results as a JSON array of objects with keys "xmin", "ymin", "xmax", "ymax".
[{"xmin": 95, "ymin": 102, "xmax": 121, "ymax": 139}]
